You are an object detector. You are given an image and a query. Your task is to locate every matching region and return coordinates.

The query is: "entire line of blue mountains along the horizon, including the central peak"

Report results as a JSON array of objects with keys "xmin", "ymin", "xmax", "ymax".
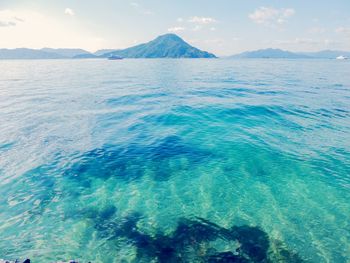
[{"xmin": 0, "ymin": 34, "xmax": 350, "ymax": 59}]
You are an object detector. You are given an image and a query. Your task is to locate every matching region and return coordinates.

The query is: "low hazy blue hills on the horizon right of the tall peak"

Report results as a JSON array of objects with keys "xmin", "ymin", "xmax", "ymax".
[{"xmin": 229, "ymin": 48, "xmax": 350, "ymax": 59}]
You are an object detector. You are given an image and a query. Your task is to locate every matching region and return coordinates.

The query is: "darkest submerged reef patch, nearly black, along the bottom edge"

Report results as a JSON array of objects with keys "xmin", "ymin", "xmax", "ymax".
[{"xmin": 94, "ymin": 212, "xmax": 303, "ymax": 263}]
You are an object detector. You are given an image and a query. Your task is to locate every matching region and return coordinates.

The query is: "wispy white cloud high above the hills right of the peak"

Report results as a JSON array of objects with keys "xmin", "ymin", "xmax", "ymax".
[{"xmin": 248, "ymin": 7, "xmax": 295, "ymax": 25}]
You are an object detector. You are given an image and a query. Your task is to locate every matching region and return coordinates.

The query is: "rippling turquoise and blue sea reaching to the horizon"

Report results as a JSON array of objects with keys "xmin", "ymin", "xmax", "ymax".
[{"xmin": 0, "ymin": 60, "xmax": 350, "ymax": 262}]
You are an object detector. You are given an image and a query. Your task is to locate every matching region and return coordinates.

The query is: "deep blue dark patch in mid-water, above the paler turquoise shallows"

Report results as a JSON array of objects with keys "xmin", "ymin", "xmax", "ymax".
[{"xmin": 64, "ymin": 136, "xmax": 212, "ymax": 187}]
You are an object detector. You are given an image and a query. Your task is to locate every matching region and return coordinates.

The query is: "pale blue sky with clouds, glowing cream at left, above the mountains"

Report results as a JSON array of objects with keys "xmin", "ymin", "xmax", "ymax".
[{"xmin": 0, "ymin": 0, "xmax": 350, "ymax": 55}]
